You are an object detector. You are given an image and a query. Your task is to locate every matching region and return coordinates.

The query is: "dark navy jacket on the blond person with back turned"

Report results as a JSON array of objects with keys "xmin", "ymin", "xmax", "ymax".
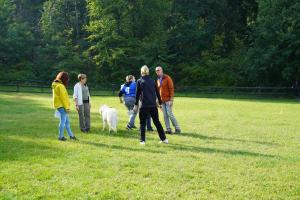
[{"xmin": 135, "ymin": 76, "xmax": 161, "ymax": 108}]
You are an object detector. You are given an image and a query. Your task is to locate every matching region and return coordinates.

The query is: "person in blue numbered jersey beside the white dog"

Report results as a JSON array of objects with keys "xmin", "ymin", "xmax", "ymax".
[{"xmin": 119, "ymin": 75, "xmax": 137, "ymax": 130}]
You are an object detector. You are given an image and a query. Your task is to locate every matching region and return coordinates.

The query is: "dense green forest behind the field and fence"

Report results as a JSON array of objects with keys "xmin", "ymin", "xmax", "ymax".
[{"xmin": 0, "ymin": 0, "xmax": 300, "ymax": 86}]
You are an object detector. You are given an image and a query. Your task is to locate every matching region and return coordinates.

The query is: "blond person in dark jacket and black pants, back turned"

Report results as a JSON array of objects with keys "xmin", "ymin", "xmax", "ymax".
[{"xmin": 134, "ymin": 65, "xmax": 169, "ymax": 145}]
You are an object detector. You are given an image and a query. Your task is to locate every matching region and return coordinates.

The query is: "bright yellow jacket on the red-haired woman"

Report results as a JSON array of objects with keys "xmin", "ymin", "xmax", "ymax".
[{"xmin": 52, "ymin": 81, "xmax": 70, "ymax": 110}]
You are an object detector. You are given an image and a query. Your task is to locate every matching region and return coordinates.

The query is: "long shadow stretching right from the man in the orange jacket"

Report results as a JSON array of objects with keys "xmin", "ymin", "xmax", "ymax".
[{"xmin": 178, "ymin": 133, "xmax": 278, "ymax": 145}]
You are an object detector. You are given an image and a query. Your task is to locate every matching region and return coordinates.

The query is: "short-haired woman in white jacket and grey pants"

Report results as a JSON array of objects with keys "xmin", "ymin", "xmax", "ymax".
[{"xmin": 73, "ymin": 74, "xmax": 91, "ymax": 133}]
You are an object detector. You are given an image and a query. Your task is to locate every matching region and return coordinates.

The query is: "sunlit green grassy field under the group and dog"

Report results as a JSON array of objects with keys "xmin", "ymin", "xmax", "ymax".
[{"xmin": 0, "ymin": 93, "xmax": 300, "ymax": 200}]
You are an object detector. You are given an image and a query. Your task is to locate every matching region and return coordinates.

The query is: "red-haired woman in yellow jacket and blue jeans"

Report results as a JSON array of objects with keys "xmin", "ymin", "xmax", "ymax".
[{"xmin": 52, "ymin": 72, "xmax": 77, "ymax": 141}]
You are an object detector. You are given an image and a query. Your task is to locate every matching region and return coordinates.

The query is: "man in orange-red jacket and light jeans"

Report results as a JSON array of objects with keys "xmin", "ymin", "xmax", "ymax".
[{"xmin": 155, "ymin": 65, "xmax": 181, "ymax": 134}]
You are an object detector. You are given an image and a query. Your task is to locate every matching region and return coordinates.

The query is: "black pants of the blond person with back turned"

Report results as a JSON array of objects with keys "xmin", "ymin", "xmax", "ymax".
[{"xmin": 139, "ymin": 107, "xmax": 166, "ymax": 141}]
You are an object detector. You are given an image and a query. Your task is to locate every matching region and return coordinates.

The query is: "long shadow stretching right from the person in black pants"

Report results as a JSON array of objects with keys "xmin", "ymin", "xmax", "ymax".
[{"xmin": 168, "ymin": 144, "xmax": 278, "ymax": 158}]
